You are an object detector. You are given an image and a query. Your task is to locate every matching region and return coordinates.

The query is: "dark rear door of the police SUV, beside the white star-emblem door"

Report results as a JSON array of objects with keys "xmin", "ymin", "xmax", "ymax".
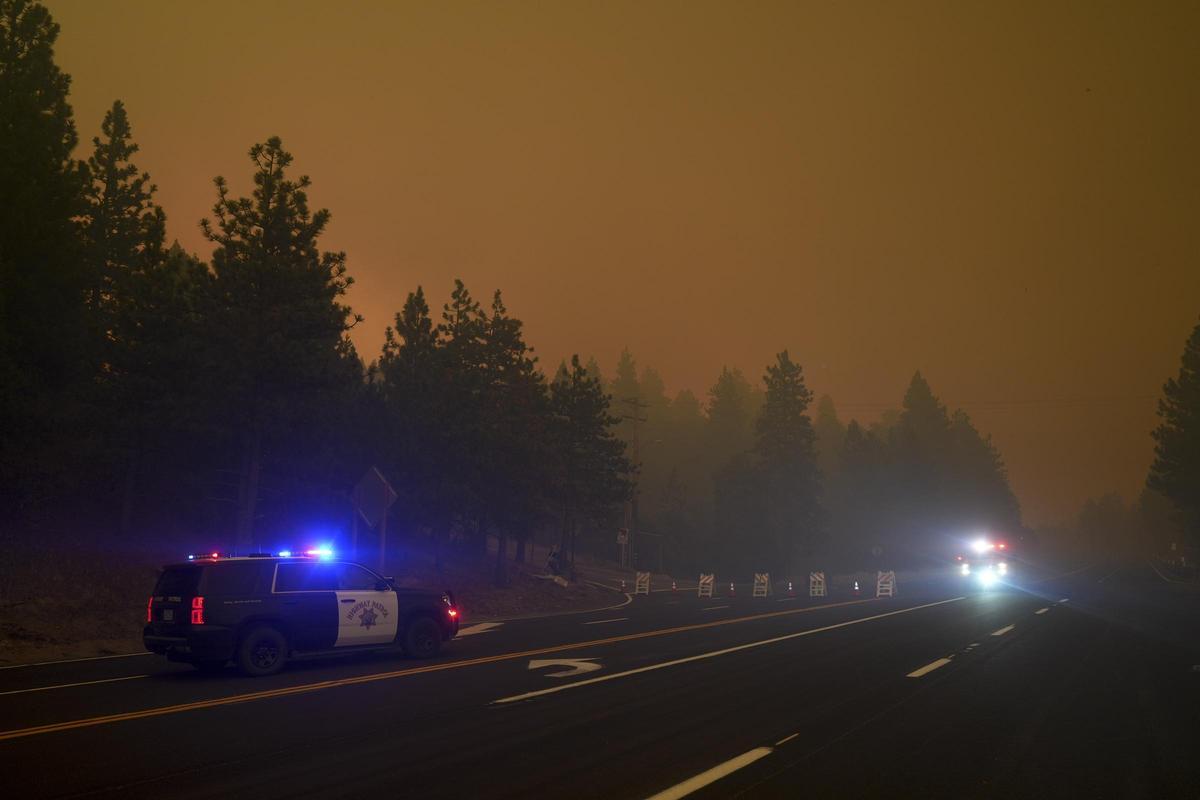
[{"xmin": 272, "ymin": 561, "xmax": 338, "ymax": 650}]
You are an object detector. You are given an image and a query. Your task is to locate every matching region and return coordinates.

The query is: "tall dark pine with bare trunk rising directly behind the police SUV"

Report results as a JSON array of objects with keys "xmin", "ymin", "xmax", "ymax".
[{"xmin": 200, "ymin": 137, "xmax": 360, "ymax": 548}]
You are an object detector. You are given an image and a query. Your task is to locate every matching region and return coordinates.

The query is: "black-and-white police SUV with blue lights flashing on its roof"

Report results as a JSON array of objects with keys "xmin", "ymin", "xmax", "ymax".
[{"xmin": 142, "ymin": 551, "xmax": 458, "ymax": 676}]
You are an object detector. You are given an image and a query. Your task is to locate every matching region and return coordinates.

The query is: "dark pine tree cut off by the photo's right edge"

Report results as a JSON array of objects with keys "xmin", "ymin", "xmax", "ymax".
[{"xmin": 1147, "ymin": 324, "xmax": 1200, "ymax": 543}]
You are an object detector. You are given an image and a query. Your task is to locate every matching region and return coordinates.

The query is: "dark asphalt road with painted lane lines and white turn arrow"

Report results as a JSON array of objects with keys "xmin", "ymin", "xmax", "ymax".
[{"xmin": 0, "ymin": 565, "xmax": 1200, "ymax": 799}]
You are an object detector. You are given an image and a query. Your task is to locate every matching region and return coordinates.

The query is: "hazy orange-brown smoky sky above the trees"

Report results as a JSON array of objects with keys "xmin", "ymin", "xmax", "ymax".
[{"xmin": 47, "ymin": 0, "xmax": 1200, "ymax": 524}]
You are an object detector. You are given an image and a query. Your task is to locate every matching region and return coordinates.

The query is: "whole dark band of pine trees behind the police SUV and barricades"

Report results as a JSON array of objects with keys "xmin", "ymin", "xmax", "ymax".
[{"xmin": 0, "ymin": 0, "xmax": 1020, "ymax": 579}]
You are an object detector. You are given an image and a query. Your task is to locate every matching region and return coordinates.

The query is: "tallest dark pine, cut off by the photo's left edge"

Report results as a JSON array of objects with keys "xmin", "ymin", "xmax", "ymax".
[{"xmin": 0, "ymin": 0, "xmax": 90, "ymax": 513}]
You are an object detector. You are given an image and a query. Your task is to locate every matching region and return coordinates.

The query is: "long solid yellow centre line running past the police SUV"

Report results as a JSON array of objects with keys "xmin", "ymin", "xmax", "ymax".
[{"xmin": 0, "ymin": 597, "xmax": 883, "ymax": 741}]
